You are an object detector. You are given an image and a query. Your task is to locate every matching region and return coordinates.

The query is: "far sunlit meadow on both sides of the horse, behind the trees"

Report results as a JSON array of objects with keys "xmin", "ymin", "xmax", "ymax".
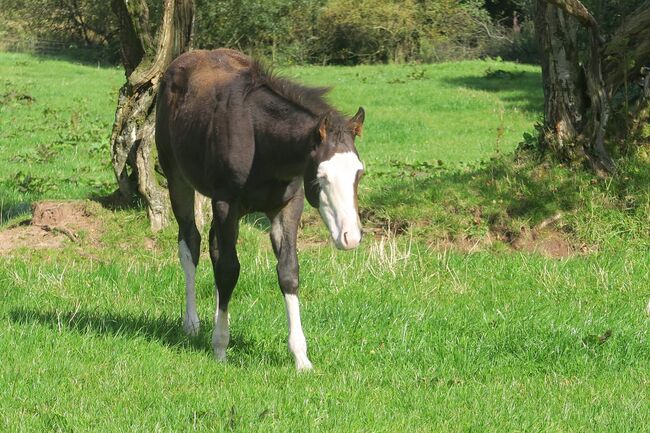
[{"xmin": 0, "ymin": 53, "xmax": 542, "ymax": 223}]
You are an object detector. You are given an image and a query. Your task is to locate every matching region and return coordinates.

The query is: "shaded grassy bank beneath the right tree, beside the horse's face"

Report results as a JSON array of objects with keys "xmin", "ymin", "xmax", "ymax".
[{"xmin": 363, "ymin": 155, "xmax": 650, "ymax": 236}]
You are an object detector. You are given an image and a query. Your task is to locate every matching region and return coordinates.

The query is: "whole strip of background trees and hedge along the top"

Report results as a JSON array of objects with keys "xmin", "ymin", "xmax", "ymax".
[{"xmin": 0, "ymin": 0, "xmax": 640, "ymax": 65}]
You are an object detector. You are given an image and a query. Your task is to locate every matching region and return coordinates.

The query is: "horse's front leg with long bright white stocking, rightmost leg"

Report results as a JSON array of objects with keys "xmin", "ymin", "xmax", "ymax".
[{"xmin": 268, "ymin": 196, "xmax": 312, "ymax": 370}]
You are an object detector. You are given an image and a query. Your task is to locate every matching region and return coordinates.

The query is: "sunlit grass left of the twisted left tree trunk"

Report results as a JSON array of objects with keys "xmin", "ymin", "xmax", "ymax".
[{"xmin": 0, "ymin": 53, "xmax": 124, "ymax": 219}]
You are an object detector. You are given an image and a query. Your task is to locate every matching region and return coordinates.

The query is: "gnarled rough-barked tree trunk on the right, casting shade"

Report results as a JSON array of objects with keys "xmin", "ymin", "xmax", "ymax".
[{"xmin": 535, "ymin": 0, "xmax": 615, "ymax": 172}]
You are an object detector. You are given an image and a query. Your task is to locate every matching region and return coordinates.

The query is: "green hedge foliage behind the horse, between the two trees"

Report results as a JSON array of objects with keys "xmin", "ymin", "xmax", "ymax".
[{"xmin": 190, "ymin": 0, "xmax": 536, "ymax": 65}]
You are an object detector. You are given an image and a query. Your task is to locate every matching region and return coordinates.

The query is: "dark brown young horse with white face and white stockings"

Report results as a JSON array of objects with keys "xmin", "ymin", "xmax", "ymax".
[{"xmin": 155, "ymin": 49, "xmax": 365, "ymax": 370}]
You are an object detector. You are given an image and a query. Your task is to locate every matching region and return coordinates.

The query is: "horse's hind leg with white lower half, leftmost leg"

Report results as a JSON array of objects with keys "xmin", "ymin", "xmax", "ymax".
[{"xmin": 168, "ymin": 177, "xmax": 201, "ymax": 337}]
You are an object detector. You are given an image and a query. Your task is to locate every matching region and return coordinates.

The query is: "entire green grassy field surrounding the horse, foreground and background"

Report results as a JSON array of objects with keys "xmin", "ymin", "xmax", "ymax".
[{"xmin": 0, "ymin": 53, "xmax": 650, "ymax": 432}]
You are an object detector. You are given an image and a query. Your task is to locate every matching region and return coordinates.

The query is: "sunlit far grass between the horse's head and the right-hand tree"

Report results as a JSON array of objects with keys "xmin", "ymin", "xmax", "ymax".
[{"xmin": 284, "ymin": 61, "xmax": 543, "ymax": 164}]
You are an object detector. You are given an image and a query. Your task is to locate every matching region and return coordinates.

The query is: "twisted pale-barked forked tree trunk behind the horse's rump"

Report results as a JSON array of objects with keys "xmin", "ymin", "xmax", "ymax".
[{"xmin": 111, "ymin": 0, "xmax": 193, "ymax": 231}]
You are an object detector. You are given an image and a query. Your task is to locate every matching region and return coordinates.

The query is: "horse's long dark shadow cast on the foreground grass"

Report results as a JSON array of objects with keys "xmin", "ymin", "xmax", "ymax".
[{"xmin": 9, "ymin": 308, "xmax": 287, "ymax": 365}]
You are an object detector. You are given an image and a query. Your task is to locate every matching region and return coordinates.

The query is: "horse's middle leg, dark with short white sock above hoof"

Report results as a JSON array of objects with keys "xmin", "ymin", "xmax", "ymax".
[{"xmin": 210, "ymin": 200, "xmax": 239, "ymax": 361}]
